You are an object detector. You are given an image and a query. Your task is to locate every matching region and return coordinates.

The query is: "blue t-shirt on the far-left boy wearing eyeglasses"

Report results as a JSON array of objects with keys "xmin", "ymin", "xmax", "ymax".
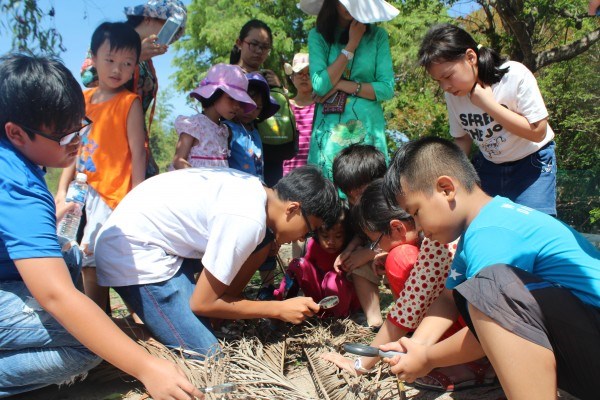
[{"xmin": 0, "ymin": 139, "xmax": 62, "ymax": 281}]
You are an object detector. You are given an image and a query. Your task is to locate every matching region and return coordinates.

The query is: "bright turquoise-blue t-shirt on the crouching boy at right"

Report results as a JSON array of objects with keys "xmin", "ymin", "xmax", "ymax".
[{"xmin": 446, "ymin": 196, "xmax": 600, "ymax": 307}]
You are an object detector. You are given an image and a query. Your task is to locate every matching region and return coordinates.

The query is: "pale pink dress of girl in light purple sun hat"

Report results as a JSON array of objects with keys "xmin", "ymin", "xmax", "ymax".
[{"xmin": 175, "ymin": 114, "xmax": 229, "ymax": 168}]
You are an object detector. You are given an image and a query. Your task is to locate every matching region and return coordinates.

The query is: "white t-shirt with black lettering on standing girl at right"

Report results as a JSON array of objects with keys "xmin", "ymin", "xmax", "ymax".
[{"xmin": 445, "ymin": 61, "xmax": 554, "ymax": 164}]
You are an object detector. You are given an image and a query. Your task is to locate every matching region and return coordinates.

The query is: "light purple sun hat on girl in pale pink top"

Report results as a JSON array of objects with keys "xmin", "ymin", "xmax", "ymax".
[{"xmin": 190, "ymin": 64, "xmax": 256, "ymax": 113}]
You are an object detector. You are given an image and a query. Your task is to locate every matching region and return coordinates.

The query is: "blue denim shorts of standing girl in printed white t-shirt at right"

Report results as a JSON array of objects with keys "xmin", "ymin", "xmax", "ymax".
[{"xmin": 473, "ymin": 141, "xmax": 557, "ymax": 216}]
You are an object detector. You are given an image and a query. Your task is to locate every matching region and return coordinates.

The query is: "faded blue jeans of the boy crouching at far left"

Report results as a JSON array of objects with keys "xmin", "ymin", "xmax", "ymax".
[{"xmin": 0, "ymin": 247, "xmax": 102, "ymax": 397}]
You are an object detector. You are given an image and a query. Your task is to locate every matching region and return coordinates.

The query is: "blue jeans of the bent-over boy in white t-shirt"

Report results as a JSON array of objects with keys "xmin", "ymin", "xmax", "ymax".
[{"xmin": 114, "ymin": 260, "xmax": 220, "ymax": 359}]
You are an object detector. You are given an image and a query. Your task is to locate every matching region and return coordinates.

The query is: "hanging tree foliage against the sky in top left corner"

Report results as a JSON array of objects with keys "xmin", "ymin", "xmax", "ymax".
[{"xmin": 0, "ymin": 0, "xmax": 66, "ymax": 55}]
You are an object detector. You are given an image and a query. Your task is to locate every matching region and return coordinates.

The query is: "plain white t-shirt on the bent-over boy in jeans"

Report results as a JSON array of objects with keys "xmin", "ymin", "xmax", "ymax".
[{"xmin": 96, "ymin": 168, "xmax": 267, "ymax": 287}]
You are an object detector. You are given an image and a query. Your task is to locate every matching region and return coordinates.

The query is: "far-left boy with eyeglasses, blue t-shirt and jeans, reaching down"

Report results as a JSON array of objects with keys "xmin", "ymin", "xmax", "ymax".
[{"xmin": 0, "ymin": 55, "xmax": 202, "ymax": 400}]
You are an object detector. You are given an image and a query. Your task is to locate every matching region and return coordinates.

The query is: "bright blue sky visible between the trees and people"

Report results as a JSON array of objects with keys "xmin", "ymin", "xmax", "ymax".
[{"xmin": 0, "ymin": 0, "xmax": 476, "ymax": 125}]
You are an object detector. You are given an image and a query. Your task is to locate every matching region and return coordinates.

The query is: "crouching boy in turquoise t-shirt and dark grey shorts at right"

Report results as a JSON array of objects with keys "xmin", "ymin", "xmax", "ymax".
[{"xmin": 382, "ymin": 137, "xmax": 600, "ymax": 400}]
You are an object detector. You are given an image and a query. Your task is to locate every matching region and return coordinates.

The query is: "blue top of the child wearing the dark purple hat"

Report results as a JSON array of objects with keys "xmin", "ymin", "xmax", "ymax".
[{"xmin": 225, "ymin": 121, "xmax": 264, "ymax": 181}]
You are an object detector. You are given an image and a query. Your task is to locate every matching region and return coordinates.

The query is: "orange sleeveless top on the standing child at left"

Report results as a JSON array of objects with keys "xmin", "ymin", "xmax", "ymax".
[{"xmin": 77, "ymin": 88, "xmax": 139, "ymax": 209}]
